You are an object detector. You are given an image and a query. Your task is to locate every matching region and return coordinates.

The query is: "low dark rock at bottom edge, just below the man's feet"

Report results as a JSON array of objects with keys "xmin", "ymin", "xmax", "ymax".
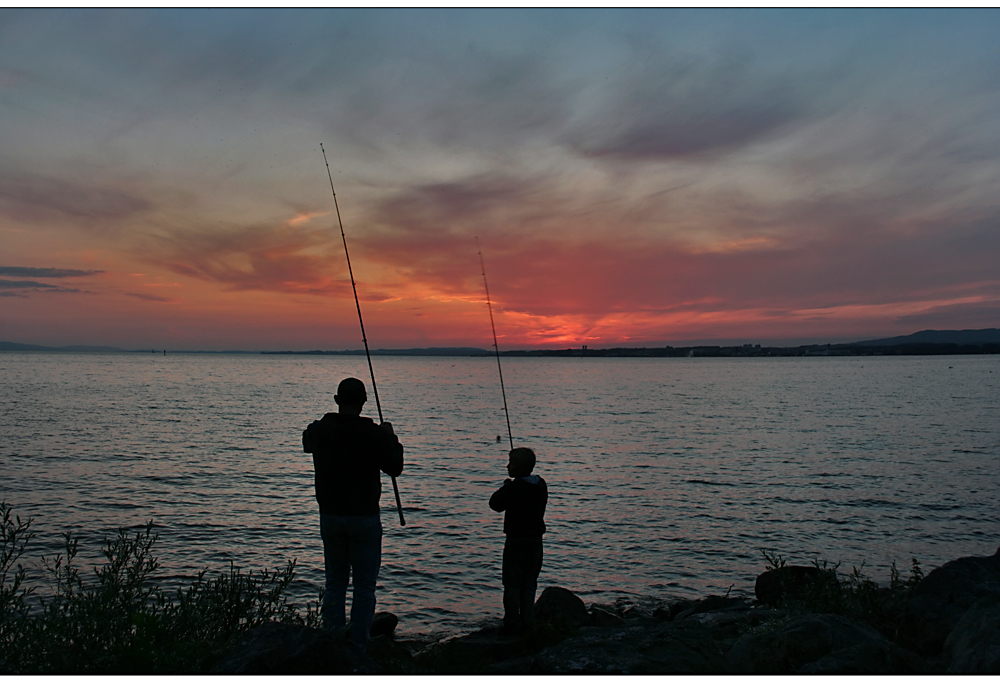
[{"xmin": 212, "ymin": 621, "xmax": 379, "ymax": 675}]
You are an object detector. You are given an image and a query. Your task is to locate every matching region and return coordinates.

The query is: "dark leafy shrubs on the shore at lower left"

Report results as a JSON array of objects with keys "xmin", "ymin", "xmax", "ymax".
[{"xmin": 0, "ymin": 502, "xmax": 319, "ymax": 674}]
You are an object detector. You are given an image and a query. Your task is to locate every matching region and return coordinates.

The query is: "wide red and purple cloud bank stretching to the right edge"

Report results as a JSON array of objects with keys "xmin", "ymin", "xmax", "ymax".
[{"xmin": 360, "ymin": 168, "xmax": 1000, "ymax": 340}]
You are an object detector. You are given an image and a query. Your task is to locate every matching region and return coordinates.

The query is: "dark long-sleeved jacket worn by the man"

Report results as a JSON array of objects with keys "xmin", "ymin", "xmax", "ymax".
[{"xmin": 302, "ymin": 413, "xmax": 403, "ymax": 517}]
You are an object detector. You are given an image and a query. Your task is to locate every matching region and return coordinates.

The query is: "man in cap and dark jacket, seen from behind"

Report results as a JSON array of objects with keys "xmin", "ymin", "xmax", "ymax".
[{"xmin": 302, "ymin": 377, "xmax": 403, "ymax": 648}]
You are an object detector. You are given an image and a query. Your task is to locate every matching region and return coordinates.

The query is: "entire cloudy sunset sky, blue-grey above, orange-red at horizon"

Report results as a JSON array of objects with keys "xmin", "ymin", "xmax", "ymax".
[{"xmin": 0, "ymin": 9, "xmax": 1000, "ymax": 350}]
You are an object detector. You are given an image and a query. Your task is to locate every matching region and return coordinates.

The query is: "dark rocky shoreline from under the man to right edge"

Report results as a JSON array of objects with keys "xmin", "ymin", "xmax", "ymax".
[{"xmin": 213, "ymin": 549, "xmax": 1000, "ymax": 674}]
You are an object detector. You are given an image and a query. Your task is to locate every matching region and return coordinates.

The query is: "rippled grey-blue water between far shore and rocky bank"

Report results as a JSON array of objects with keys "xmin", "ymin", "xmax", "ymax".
[{"xmin": 0, "ymin": 353, "xmax": 1000, "ymax": 636}]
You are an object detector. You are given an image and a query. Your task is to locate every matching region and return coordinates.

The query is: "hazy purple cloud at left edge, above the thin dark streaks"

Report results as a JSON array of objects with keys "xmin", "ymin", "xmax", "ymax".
[{"xmin": 0, "ymin": 173, "xmax": 153, "ymax": 225}]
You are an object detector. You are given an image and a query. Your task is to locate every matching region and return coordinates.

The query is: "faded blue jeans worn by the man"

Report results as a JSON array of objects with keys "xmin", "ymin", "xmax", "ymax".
[{"xmin": 319, "ymin": 514, "xmax": 382, "ymax": 645}]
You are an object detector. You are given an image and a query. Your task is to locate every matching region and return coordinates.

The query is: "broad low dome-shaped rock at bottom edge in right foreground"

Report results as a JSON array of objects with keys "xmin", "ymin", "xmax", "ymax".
[{"xmin": 728, "ymin": 614, "xmax": 923, "ymax": 674}]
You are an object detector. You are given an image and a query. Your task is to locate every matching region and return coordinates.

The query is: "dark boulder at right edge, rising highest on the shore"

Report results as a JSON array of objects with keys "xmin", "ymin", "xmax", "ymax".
[{"xmin": 900, "ymin": 550, "xmax": 1000, "ymax": 656}]
